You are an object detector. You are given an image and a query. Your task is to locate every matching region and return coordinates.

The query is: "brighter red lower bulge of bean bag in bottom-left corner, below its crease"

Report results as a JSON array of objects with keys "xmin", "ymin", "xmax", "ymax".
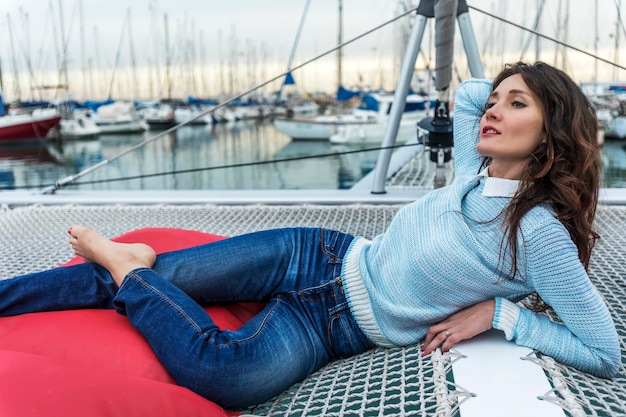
[{"xmin": 0, "ymin": 347, "xmax": 235, "ymax": 417}]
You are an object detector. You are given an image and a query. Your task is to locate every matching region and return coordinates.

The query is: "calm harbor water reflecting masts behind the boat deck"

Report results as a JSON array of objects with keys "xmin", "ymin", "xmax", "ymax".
[{"xmin": 0, "ymin": 121, "xmax": 626, "ymax": 191}]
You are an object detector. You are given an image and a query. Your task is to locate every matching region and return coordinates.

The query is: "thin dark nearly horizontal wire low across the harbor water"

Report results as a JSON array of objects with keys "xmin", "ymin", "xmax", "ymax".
[{"xmin": 0, "ymin": 142, "xmax": 422, "ymax": 191}]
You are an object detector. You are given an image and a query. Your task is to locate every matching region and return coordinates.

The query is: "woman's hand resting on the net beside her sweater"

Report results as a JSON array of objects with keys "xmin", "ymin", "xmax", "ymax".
[{"xmin": 422, "ymin": 300, "xmax": 496, "ymax": 356}]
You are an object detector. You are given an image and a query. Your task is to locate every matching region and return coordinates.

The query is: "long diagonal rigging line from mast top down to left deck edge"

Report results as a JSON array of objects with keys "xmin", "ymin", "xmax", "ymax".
[{"xmin": 40, "ymin": 9, "xmax": 417, "ymax": 194}]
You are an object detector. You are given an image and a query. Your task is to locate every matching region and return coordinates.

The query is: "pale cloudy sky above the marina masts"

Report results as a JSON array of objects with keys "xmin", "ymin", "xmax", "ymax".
[{"xmin": 0, "ymin": 0, "xmax": 626, "ymax": 99}]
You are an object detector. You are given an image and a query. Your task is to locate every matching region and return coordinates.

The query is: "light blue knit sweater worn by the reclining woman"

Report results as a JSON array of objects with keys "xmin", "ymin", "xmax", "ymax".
[{"xmin": 342, "ymin": 79, "xmax": 621, "ymax": 377}]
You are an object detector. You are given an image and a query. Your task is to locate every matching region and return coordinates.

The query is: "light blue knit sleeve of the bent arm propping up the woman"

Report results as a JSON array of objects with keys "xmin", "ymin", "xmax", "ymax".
[{"xmin": 492, "ymin": 219, "xmax": 621, "ymax": 378}]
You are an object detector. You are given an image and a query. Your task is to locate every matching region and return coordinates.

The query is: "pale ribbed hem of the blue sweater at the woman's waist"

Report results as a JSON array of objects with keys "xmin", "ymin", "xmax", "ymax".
[{"xmin": 341, "ymin": 238, "xmax": 394, "ymax": 347}]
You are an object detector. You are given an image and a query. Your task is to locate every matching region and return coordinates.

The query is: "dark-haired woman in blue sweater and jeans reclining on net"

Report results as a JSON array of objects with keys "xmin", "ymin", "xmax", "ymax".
[{"xmin": 0, "ymin": 63, "xmax": 620, "ymax": 408}]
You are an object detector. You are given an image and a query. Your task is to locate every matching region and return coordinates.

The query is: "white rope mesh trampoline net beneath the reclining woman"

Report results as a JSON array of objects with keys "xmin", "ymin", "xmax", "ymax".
[{"xmin": 0, "ymin": 205, "xmax": 626, "ymax": 417}]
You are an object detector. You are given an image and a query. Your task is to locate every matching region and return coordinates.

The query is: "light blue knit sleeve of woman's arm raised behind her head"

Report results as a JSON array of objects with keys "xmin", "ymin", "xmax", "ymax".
[{"xmin": 453, "ymin": 78, "xmax": 491, "ymax": 175}]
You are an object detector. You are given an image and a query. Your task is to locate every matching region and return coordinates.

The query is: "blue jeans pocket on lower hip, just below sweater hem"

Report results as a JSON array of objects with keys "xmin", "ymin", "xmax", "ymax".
[{"xmin": 328, "ymin": 302, "xmax": 374, "ymax": 359}]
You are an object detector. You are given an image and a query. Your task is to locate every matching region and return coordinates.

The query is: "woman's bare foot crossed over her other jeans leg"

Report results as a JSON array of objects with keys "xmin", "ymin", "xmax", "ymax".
[{"xmin": 68, "ymin": 226, "xmax": 156, "ymax": 285}]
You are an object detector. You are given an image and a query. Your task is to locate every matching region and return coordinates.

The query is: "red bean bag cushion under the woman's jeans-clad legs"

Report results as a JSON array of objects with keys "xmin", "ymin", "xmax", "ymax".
[{"xmin": 0, "ymin": 228, "xmax": 262, "ymax": 417}]
